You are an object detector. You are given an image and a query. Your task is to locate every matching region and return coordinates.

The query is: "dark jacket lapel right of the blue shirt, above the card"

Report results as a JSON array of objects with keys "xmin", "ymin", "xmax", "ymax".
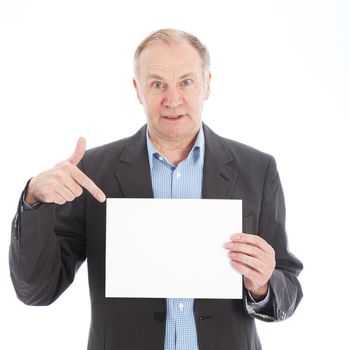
[{"xmin": 202, "ymin": 124, "xmax": 238, "ymax": 199}]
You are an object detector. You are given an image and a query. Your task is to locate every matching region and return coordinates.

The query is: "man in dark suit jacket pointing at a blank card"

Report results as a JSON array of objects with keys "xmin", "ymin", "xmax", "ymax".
[{"xmin": 10, "ymin": 30, "xmax": 302, "ymax": 350}]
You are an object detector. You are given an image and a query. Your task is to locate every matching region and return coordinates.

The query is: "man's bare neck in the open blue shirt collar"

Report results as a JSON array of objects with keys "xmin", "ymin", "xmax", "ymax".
[{"xmin": 149, "ymin": 131, "xmax": 198, "ymax": 165}]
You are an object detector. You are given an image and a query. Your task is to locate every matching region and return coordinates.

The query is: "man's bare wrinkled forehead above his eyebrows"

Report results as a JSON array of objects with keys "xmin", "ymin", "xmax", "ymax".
[{"xmin": 138, "ymin": 40, "xmax": 202, "ymax": 77}]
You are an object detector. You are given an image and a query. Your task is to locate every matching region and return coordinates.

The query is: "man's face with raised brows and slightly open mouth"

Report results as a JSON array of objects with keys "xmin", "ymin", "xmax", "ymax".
[{"xmin": 134, "ymin": 40, "xmax": 210, "ymax": 143}]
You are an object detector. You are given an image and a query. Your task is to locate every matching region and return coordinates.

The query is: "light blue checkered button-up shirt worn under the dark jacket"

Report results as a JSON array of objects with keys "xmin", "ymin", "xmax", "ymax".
[{"xmin": 147, "ymin": 128, "xmax": 204, "ymax": 350}]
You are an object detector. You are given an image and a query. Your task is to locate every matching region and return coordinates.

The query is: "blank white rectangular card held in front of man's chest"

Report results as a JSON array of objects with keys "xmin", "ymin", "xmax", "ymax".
[{"xmin": 106, "ymin": 198, "xmax": 242, "ymax": 299}]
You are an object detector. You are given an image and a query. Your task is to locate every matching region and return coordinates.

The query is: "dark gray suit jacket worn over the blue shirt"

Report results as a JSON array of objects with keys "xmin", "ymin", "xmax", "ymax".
[{"xmin": 10, "ymin": 125, "xmax": 302, "ymax": 350}]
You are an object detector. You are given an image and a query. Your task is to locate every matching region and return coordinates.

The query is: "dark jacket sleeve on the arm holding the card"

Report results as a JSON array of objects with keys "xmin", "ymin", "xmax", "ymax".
[{"xmin": 244, "ymin": 157, "xmax": 303, "ymax": 322}]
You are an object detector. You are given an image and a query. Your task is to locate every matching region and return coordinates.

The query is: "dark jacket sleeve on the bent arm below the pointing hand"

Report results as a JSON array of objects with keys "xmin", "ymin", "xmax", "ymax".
[{"xmin": 9, "ymin": 182, "xmax": 86, "ymax": 305}]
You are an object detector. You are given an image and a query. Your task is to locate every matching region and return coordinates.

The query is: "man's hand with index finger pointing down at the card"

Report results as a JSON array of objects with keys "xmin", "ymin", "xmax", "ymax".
[{"xmin": 24, "ymin": 137, "xmax": 106, "ymax": 205}]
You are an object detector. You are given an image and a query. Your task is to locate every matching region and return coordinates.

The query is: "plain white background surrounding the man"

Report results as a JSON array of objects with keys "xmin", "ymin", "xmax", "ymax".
[{"xmin": 0, "ymin": 0, "xmax": 350, "ymax": 350}]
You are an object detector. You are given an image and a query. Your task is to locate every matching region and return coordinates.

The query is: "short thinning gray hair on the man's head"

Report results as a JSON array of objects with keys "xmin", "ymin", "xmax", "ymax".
[{"xmin": 134, "ymin": 29, "xmax": 210, "ymax": 76}]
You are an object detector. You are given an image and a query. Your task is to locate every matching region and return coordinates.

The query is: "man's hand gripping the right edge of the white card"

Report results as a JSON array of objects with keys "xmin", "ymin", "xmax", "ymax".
[{"xmin": 224, "ymin": 233, "xmax": 276, "ymax": 301}]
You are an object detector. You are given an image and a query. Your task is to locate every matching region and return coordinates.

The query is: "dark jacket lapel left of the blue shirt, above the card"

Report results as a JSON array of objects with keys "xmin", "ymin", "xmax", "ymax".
[{"xmin": 115, "ymin": 126, "xmax": 153, "ymax": 198}]
